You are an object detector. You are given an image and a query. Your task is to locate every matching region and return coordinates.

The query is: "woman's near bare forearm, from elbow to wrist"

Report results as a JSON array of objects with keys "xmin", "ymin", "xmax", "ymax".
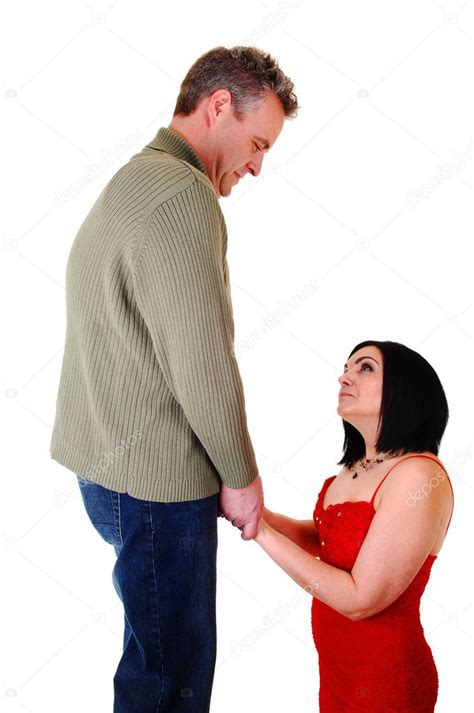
[{"xmin": 255, "ymin": 520, "xmax": 358, "ymax": 619}]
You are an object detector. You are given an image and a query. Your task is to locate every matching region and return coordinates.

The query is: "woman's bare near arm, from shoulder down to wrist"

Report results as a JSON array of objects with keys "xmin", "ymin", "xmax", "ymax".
[{"xmin": 255, "ymin": 459, "xmax": 451, "ymax": 621}]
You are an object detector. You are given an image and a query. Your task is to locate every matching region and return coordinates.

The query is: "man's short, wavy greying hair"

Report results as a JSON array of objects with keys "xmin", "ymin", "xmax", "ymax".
[{"xmin": 174, "ymin": 47, "xmax": 298, "ymax": 118}]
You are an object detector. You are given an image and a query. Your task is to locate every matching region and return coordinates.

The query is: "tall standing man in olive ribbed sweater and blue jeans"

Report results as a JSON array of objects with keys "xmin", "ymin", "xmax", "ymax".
[{"xmin": 51, "ymin": 47, "xmax": 297, "ymax": 713}]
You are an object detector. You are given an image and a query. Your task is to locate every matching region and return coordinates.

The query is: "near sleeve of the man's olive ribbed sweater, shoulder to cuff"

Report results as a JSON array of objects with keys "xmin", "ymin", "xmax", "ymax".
[{"xmin": 134, "ymin": 181, "xmax": 258, "ymax": 488}]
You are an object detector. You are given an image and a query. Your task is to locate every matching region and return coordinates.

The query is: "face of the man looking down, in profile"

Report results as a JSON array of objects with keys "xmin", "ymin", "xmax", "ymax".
[{"xmin": 210, "ymin": 91, "xmax": 285, "ymax": 198}]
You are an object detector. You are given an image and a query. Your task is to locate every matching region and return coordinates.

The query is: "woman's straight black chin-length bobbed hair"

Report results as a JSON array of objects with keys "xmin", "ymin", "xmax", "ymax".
[{"xmin": 338, "ymin": 341, "xmax": 449, "ymax": 467}]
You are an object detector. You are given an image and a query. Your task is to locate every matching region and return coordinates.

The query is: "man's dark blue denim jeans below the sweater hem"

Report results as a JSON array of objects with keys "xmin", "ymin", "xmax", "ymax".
[{"xmin": 77, "ymin": 476, "xmax": 218, "ymax": 713}]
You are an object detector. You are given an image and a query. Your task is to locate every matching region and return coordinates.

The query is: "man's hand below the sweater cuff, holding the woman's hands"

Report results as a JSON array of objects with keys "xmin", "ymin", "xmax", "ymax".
[{"xmin": 219, "ymin": 475, "xmax": 263, "ymax": 540}]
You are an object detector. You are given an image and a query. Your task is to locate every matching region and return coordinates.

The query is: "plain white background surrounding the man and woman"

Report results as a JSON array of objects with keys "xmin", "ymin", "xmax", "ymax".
[{"xmin": 0, "ymin": 0, "xmax": 474, "ymax": 713}]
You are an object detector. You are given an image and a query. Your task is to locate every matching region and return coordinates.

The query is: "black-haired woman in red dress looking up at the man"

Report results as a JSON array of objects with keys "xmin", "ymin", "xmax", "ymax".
[{"xmin": 255, "ymin": 341, "xmax": 454, "ymax": 713}]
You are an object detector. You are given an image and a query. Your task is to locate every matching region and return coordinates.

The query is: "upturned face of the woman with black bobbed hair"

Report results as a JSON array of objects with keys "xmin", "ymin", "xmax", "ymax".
[{"xmin": 337, "ymin": 346, "xmax": 383, "ymax": 428}]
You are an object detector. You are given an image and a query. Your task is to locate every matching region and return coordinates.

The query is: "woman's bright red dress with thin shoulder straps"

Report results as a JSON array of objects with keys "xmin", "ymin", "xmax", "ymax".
[{"xmin": 311, "ymin": 455, "xmax": 452, "ymax": 713}]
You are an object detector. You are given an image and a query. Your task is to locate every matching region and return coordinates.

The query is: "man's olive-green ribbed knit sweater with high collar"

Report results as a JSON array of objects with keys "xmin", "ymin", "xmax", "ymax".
[{"xmin": 50, "ymin": 128, "xmax": 258, "ymax": 502}]
